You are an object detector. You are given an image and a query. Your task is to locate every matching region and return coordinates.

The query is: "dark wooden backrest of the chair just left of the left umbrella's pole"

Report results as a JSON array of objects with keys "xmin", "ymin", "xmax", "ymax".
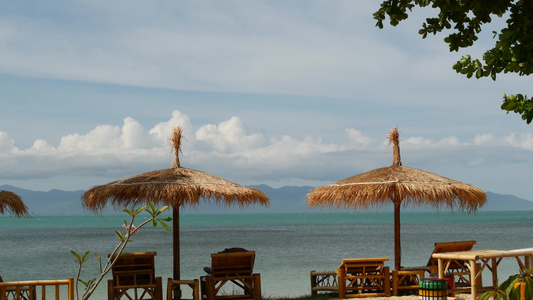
[{"xmin": 108, "ymin": 252, "xmax": 157, "ymax": 286}]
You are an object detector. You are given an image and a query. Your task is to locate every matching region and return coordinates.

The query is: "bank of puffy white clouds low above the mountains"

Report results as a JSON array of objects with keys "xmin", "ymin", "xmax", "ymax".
[{"xmin": 0, "ymin": 110, "xmax": 533, "ymax": 199}]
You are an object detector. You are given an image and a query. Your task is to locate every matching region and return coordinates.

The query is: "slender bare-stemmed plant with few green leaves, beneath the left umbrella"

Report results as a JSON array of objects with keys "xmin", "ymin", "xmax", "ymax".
[{"xmin": 70, "ymin": 203, "xmax": 172, "ymax": 300}]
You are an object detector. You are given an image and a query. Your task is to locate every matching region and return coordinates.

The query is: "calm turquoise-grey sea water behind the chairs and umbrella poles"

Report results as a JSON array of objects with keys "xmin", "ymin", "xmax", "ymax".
[{"xmin": 0, "ymin": 211, "xmax": 533, "ymax": 299}]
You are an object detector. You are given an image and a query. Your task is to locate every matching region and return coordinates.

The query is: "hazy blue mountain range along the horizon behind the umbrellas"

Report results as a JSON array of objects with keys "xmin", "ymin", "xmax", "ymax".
[{"xmin": 0, "ymin": 185, "xmax": 533, "ymax": 215}]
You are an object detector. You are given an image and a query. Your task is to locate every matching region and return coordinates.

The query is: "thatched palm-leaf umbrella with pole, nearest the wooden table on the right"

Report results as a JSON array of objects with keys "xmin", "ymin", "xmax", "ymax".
[{"xmin": 307, "ymin": 128, "xmax": 487, "ymax": 270}]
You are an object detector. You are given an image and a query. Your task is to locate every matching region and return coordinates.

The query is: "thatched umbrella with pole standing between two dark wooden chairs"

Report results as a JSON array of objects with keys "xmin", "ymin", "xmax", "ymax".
[{"xmin": 82, "ymin": 126, "xmax": 269, "ymax": 280}]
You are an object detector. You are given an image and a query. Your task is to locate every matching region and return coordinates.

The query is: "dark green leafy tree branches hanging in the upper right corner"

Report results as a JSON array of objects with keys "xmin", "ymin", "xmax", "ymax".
[{"xmin": 374, "ymin": 0, "xmax": 533, "ymax": 124}]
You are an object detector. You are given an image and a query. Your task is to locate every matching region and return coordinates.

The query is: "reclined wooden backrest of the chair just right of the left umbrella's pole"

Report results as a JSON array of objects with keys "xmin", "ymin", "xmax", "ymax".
[{"xmin": 211, "ymin": 251, "xmax": 255, "ymax": 277}]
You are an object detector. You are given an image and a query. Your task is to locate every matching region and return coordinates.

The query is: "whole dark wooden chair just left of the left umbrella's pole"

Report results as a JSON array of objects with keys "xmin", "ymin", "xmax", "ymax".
[{"xmin": 107, "ymin": 252, "xmax": 163, "ymax": 300}]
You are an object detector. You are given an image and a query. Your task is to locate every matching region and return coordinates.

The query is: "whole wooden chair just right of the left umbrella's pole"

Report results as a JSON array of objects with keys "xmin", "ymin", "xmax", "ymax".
[{"xmin": 200, "ymin": 251, "xmax": 261, "ymax": 300}]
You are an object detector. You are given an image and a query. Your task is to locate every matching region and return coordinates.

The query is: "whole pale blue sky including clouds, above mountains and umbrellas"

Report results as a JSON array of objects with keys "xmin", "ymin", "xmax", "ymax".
[{"xmin": 0, "ymin": 0, "xmax": 533, "ymax": 200}]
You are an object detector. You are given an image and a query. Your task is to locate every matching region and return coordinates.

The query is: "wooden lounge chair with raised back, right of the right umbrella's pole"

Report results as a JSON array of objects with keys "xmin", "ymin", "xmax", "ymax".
[{"xmin": 392, "ymin": 241, "xmax": 481, "ymax": 296}]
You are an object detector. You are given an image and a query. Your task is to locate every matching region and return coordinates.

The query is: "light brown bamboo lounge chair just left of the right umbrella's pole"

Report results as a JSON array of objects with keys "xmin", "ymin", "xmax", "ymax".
[{"xmin": 337, "ymin": 257, "xmax": 391, "ymax": 299}]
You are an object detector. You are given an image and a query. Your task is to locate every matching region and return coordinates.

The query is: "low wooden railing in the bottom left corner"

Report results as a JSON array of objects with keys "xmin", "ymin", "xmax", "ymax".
[{"xmin": 0, "ymin": 278, "xmax": 74, "ymax": 300}]
